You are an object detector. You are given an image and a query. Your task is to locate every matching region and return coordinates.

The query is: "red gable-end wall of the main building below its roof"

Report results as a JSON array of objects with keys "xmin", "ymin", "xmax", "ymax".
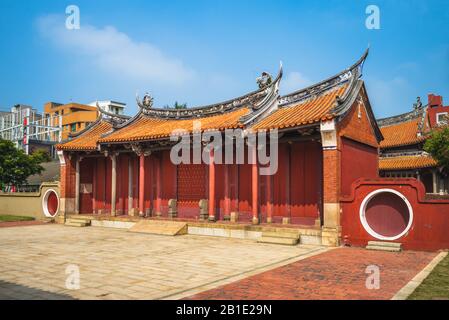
[{"xmin": 341, "ymin": 138, "xmax": 378, "ymax": 196}]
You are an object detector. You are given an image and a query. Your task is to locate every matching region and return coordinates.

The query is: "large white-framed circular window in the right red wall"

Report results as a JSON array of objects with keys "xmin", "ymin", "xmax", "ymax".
[{"xmin": 360, "ymin": 189, "xmax": 413, "ymax": 240}]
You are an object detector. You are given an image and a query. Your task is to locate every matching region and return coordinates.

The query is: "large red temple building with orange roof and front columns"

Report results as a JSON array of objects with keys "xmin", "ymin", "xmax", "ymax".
[{"xmin": 54, "ymin": 51, "xmax": 383, "ymax": 245}]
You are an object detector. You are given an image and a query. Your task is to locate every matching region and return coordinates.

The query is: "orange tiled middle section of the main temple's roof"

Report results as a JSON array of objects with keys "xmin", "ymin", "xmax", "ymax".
[{"xmin": 99, "ymin": 108, "xmax": 249, "ymax": 143}]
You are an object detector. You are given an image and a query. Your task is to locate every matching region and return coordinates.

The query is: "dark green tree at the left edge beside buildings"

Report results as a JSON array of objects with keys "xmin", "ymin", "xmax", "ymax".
[{"xmin": 0, "ymin": 139, "xmax": 50, "ymax": 187}]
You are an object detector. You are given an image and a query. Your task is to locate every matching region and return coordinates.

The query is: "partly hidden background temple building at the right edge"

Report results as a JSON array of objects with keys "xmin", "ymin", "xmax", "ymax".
[{"xmin": 377, "ymin": 94, "xmax": 449, "ymax": 194}]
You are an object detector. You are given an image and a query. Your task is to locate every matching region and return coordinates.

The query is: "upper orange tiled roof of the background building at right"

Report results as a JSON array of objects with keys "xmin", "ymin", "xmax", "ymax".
[{"xmin": 380, "ymin": 118, "xmax": 425, "ymax": 148}]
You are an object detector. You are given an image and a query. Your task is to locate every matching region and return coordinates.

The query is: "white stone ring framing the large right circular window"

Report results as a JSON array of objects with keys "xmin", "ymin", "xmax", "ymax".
[{"xmin": 359, "ymin": 189, "xmax": 413, "ymax": 241}]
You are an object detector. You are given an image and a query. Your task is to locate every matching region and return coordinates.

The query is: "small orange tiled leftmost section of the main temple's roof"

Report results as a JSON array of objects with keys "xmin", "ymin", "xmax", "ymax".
[{"xmin": 56, "ymin": 121, "xmax": 112, "ymax": 151}]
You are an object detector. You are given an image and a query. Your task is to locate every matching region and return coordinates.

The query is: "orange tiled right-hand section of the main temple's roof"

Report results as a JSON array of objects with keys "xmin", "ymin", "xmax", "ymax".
[{"xmin": 253, "ymin": 84, "xmax": 348, "ymax": 130}]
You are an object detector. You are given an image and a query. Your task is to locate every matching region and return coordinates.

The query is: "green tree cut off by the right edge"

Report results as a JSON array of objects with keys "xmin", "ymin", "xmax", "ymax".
[{"xmin": 424, "ymin": 125, "xmax": 449, "ymax": 173}]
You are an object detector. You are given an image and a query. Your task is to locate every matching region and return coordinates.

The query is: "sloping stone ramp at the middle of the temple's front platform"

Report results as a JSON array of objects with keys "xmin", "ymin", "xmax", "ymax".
[{"xmin": 128, "ymin": 220, "xmax": 187, "ymax": 236}]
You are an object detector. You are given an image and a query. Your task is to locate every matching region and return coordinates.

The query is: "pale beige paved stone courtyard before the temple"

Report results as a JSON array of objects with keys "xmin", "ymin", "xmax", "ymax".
[{"xmin": 0, "ymin": 225, "xmax": 326, "ymax": 299}]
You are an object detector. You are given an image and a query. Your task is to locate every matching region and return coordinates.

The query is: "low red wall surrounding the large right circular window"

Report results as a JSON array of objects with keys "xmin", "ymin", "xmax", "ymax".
[{"xmin": 341, "ymin": 179, "xmax": 449, "ymax": 250}]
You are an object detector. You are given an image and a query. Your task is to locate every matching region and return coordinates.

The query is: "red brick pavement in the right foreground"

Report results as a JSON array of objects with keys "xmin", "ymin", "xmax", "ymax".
[{"xmin": 187, "ymin": 248, "xmax": 437, "ymax": 300}]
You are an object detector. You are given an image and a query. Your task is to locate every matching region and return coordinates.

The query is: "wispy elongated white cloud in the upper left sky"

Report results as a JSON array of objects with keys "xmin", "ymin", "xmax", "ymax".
[{"xmin": 37, "ymin": 15, "xmax": 195, "ymax": 84}]
